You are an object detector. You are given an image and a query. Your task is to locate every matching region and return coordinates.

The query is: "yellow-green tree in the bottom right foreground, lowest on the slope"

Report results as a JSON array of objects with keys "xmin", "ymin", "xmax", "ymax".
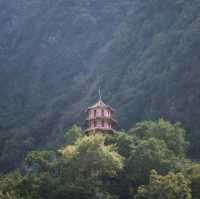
[{"xmin": 134, "ymin": 170, "xmax": 192, "ymax": 199}]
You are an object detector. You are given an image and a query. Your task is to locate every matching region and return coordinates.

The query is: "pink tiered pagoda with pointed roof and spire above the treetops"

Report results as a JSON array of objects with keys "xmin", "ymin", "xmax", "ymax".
[{"xmin": 85, "ymin": 91, "xmax": 117, "ymax": 134}]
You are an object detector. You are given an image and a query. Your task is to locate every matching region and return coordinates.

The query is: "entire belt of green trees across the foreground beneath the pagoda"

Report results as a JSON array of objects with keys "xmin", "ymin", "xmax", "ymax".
[{"xmin": 0, "ymin": 119, "xmax": 200, "ymax": 199}]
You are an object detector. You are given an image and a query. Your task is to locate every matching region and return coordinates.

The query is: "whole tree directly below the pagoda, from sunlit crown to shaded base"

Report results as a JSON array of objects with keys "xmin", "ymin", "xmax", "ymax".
[{"xmin": 61, "ymin": 135, "xmax": 124, "ymax": 198}]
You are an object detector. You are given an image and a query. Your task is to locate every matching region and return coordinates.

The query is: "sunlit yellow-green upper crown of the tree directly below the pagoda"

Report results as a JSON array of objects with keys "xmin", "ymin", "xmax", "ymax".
[{"xmin": 63, "ymin": 135, "xmax": 123, "ymax": 177}]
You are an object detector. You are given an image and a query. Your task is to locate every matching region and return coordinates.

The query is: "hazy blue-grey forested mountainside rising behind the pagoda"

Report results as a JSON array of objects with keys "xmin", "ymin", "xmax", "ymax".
[{"xmin": 0, "ymin": 0, "xmax": 200, "ymax": 171}]
